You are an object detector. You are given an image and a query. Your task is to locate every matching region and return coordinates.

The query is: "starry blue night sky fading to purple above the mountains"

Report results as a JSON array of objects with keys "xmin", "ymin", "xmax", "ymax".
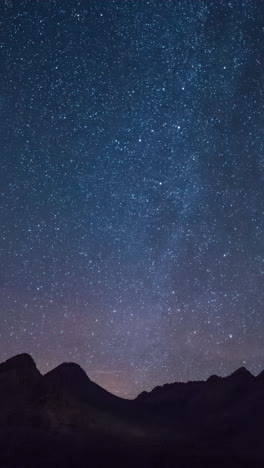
[{"xmin": 0, "ymin": 0, "xmax": 264, "ymax": 397}]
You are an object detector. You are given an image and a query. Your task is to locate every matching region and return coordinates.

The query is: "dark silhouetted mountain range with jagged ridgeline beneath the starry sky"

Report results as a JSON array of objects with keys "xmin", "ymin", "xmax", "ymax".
[{"xmin": 0, "ymin": 354, "xmax": 264, "ymax": 468}]
